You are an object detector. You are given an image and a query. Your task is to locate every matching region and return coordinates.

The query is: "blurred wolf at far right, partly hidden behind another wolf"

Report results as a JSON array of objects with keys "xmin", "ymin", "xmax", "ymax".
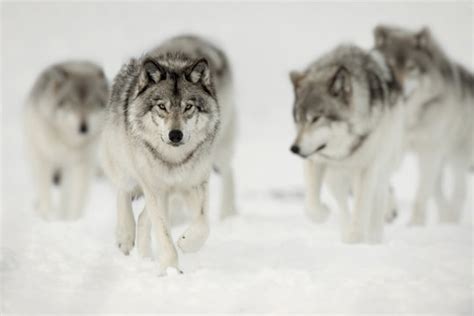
[{"xmin": 374, "ymin": 25, "xmax": 474, "ymax": 225}]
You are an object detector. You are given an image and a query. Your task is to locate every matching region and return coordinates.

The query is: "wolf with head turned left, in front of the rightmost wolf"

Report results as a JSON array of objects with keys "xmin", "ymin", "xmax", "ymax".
[{"xmin": 290, "ymin": 45, "xmax": 403, "ymax": 243}]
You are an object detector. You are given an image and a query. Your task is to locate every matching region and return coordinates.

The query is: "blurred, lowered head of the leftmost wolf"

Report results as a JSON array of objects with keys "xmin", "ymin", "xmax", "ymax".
[{"xmin": 41, "ymin": 62, "xmax": 108, "ymax": 145}]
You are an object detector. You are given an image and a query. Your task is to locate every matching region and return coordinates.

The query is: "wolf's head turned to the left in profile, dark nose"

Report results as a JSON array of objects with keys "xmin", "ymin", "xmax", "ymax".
[{"xmin": 290, "ymin": 46, "xmax": 387, "ymax": 160}]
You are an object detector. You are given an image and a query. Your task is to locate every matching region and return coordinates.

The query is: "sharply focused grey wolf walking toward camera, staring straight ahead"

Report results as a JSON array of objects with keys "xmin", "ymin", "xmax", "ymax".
[{"xmin": 100, "ymin": 36, "xmax": 235, "ymax": 275}]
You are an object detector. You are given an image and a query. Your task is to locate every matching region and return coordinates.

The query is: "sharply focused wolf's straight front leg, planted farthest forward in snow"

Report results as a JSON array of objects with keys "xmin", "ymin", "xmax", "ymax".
[{"xmin": 143, "ymin": 188, "xmax": 180, "ymax": 275}]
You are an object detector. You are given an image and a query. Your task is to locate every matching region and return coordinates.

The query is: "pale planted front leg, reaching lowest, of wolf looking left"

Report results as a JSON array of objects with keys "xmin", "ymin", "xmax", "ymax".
[{"xmin": 345, "ymin": 168, "xmax": 377, "ymax": 243}]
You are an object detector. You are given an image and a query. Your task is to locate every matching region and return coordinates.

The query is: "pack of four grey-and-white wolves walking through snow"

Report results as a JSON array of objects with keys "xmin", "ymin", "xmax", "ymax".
[{"xmin": 24, "ymin": 25, "xmax": 474, "ymax": 275}]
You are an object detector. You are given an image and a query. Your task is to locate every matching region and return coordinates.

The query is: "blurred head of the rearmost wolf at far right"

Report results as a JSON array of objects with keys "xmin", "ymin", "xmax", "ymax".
[{"xmin": 374, "ymin": 25, "xmax": 444, "ymax": 97}]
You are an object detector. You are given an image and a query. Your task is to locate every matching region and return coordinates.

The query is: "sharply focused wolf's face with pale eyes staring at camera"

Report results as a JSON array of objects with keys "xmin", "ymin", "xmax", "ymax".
[{"xmin": 127, "ymin": 54, "xmax": 219, "ymax": 158}]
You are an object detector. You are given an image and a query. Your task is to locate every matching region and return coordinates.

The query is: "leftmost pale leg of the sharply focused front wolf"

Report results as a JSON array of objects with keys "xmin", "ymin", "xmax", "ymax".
[{"xmin": 115, "ymin": 191, "xmax": 135, "ymax": 256}]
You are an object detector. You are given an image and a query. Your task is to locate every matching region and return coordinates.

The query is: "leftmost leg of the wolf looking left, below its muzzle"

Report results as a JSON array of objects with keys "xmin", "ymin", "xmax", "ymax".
[{"xmin": 304, "ymin": 160, "xmax": 329, "ymax": 223}]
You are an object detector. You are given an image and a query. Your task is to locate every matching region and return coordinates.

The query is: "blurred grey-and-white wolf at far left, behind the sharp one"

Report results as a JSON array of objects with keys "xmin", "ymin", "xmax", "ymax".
[{"xmin": 24, "ymin": 61, "xmax": 109, "ymax": 220}]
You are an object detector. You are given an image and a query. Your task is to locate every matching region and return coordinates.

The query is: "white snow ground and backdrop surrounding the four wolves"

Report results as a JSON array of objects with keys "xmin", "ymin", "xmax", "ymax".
[{"xmin": 0, "ymin": 3, "xmax": 474, "ymax": 315}]
